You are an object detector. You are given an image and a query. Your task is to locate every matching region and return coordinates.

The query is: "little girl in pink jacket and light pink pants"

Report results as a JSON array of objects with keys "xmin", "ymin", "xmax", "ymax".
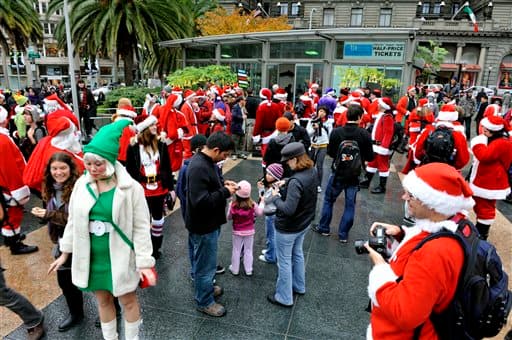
[{"xmin": 228, "ymin": 181, "xmax": 264, "ymax": 276}]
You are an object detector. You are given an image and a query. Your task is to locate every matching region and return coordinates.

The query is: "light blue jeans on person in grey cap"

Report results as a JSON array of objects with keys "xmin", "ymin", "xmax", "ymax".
[{"xmin": 274, "ymin": 228, "xmax": 308, "ymax": 306}]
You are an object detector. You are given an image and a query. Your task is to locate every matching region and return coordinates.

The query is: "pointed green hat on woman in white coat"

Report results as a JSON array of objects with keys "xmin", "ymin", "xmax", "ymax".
[{"xmin": 84, "ymin": 119, "xmax": 132, "ymax": 164}]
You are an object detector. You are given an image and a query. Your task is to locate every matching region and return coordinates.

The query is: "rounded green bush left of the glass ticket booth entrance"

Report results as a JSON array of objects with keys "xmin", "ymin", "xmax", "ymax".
[{"xmin": 167, "ymin": 65, "xmax": 237, "ymax": 89}]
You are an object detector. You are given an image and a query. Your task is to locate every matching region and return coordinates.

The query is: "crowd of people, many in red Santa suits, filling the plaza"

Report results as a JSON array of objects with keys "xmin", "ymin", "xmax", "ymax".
[{"xmin": 0, "ymin": 81, "xmax": 512, "ymax": 339}]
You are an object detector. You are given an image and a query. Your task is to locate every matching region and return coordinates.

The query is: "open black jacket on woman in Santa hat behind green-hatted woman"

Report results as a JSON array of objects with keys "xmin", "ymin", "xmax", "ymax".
[{"xmin": 126, "ymin": 141, "xmax": 174, "ymax": 191}]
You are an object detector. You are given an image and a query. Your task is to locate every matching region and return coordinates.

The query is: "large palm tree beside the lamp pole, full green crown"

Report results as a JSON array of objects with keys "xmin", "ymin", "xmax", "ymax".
[{"xmin": 48, "ymin": 0, "xmax": 194, "ymax": 85}]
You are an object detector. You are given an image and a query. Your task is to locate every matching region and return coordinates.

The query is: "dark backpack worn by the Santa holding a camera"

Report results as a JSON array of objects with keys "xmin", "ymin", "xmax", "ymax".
[{"xmin": 413, "ymin": 218, "xmax": 512, "ymax": 340}]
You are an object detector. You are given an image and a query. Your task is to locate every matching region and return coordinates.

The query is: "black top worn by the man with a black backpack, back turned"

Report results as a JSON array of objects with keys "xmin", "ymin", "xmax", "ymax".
[{"xmin": 327, "ymin": 123, "xmax": 374, "ymax": 185}]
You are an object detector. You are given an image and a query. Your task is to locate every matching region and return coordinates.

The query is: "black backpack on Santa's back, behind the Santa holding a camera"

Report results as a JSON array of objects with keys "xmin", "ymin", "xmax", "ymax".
[{"xmin": 422, "ymin": 126, "xmax": 455, "ymax": 165}]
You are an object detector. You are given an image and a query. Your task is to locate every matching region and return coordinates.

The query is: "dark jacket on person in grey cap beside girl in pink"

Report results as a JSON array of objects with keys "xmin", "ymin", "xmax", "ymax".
[{"xmin": 273, "ymin": 168, "xmax": 318, "ymax": 233}]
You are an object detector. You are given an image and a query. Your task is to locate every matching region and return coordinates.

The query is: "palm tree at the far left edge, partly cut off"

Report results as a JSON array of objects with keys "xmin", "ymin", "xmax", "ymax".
[{"xmin": 0, "ymin": 0, "xmax": 43, "ymax": 88}]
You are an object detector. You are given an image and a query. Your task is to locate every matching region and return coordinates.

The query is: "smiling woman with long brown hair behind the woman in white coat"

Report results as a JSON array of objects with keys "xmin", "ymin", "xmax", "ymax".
[{"xmin": 32, "ymin": 152, "xmax": 84, "ymax": 332}]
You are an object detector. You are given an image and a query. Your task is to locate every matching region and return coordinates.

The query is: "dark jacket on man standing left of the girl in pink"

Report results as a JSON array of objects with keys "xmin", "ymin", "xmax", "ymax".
[{"xmin": 185, "ymin": 152, "xmax": 231, "ymax": 235}]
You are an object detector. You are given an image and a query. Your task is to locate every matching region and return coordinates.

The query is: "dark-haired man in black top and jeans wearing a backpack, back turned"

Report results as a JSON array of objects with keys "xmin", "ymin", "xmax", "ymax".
[{"xmin": 313, "ymin": 105, "xmax": 374, "ymax": 243}]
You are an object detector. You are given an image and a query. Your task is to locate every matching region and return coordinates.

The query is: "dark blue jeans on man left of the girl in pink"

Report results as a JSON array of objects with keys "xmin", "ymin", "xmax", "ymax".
[{"xmin": 189, "ymin": 229, "xmax": 220, "ymax": 307}]
